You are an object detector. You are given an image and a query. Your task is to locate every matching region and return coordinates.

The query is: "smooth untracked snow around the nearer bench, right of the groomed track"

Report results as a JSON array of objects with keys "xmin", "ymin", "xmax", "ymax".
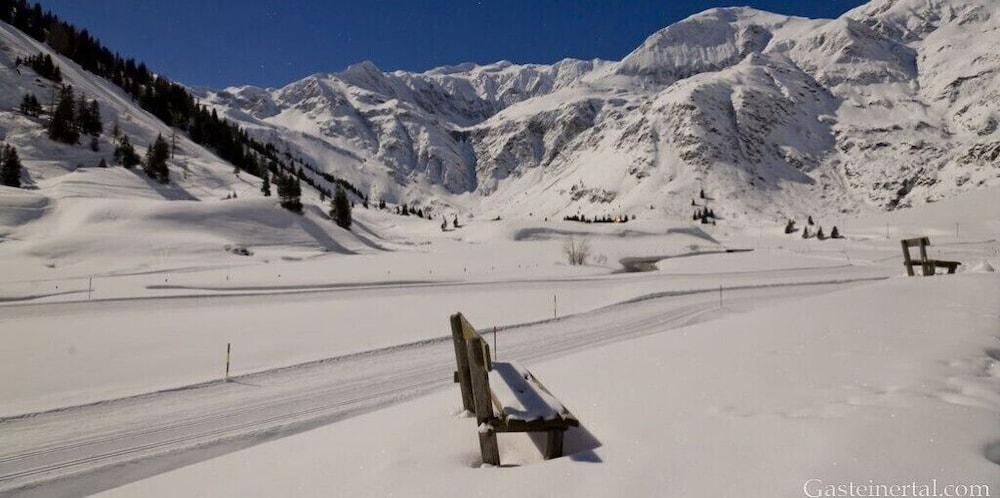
[{"xmin": 95, "ymin": 275, "xmax": 1000, "ymax": 496}]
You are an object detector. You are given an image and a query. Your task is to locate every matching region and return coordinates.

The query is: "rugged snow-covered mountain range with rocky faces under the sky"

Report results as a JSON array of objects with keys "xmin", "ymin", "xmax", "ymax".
[{"xmin": 202, "ymin": 0, "xmax": 1000, "ymax": 221}]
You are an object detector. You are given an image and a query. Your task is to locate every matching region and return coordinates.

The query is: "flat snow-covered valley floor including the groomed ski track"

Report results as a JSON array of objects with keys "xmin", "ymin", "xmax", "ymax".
[{"xmin": 0, "ymin": 190, "xmax": 1000, "ymax": 496}]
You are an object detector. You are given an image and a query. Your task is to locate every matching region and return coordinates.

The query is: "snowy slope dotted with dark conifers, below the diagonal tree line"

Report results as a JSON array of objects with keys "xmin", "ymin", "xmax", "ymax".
[{"xmin": 0, "ymin": 23, "xmax": 376, "ymax": 278}]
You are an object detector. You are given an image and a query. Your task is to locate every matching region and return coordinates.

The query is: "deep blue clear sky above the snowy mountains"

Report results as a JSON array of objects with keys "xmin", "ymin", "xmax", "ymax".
[{"xmin": 42, "ymin": 0, "xmax": 864, "ymax": 87}]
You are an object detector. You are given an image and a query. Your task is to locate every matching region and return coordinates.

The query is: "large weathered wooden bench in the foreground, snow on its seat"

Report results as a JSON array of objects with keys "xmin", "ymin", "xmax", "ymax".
[{"xmin": 451, "ymin": 313, "xmax": 580, "ymax": 465}]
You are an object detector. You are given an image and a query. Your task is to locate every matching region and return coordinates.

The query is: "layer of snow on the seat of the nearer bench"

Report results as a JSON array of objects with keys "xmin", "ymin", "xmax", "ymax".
[{"xmin": 489, "ymin": 362, "xmax": 576, "ymax": 425}]
